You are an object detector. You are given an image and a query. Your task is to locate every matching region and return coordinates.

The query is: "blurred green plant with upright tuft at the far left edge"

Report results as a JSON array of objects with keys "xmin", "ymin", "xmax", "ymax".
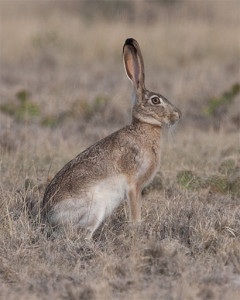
[{"xmin": 0, "ymin": 90, "xmax": 40, "ymax": 121}]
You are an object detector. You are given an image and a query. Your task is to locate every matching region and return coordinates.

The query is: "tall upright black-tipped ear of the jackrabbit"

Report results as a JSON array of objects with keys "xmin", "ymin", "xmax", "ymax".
[{"xmin": 123, "ymin": 38, "xmax": 144, "ymax": 90}]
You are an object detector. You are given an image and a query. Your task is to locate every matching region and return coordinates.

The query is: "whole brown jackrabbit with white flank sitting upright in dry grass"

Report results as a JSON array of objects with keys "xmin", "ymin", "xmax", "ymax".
[{"xmin": 43, "ymin": 38, "xmax": 181, "ymax": 238}]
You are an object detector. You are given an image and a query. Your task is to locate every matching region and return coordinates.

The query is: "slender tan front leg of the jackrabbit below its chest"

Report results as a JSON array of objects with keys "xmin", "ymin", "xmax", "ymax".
[{"xmin": 128, "ymin": 188, "xmax": 142, "ymax": 222}]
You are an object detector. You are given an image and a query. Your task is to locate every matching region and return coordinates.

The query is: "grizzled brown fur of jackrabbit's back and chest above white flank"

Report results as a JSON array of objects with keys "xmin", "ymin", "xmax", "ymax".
[{"xmin": 43, "ymin": 120, "xmax": 161, "ymax": 213}]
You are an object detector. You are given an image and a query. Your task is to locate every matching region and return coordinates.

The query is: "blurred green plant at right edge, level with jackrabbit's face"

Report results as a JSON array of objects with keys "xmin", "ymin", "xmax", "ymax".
[{"xmin": 204, "ymin": 83, "xmax": 240, "ymax": 116}]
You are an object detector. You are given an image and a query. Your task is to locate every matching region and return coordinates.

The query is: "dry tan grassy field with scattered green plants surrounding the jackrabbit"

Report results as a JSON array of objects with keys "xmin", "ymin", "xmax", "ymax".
[{"xmin": 0, "ymin": 0, "xmax": 240, "ymax": 300}]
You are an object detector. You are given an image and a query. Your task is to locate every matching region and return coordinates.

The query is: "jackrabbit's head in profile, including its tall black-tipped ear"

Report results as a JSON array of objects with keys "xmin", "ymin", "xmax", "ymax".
[{"xmin": 123, "ymin": 38, "xmax": 182, "ymax": 126}]
